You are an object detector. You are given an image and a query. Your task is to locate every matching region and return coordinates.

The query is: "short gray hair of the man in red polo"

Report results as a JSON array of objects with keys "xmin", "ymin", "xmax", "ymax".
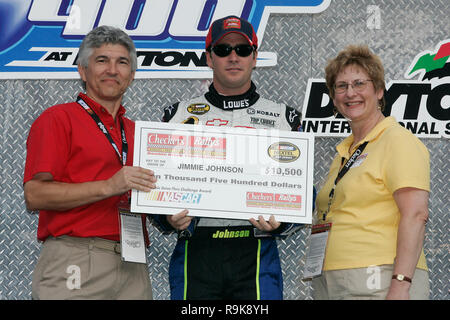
[{"xmin": 77, "ymin": 26, "xmax": 137, "ymax": 71}]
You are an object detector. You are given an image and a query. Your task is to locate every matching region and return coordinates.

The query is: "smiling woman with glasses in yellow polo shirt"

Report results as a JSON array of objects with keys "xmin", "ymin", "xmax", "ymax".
[{"xmin": 313, "ymin": 45, "xmax": 430, "ymax": 299}]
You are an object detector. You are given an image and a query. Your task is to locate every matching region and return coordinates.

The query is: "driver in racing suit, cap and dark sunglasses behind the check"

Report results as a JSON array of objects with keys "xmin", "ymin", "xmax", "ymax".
[{"xmin": 154, "ymin": 16, "xmax": 308, "ymax": 300}]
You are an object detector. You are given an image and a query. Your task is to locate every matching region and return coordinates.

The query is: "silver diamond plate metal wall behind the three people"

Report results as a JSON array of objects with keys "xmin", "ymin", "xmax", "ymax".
[{"xmin": 0, "ymin": 0, "xmax": 450, "ymax": 300}]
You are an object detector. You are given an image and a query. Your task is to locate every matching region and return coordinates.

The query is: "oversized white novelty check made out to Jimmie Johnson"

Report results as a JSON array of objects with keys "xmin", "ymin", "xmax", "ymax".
[{"xmin": 131, "ymin": 121, "xmax": 314, "ymax": 224}]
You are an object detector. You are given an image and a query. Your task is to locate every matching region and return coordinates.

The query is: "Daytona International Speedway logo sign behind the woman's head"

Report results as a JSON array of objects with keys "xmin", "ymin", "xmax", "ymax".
[{"xmin": 302, "ymin": 39, "xmax": 450, "ymax": 138}]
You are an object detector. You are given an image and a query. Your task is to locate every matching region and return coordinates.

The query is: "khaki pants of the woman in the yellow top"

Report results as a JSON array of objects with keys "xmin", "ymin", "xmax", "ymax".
[{"xmin": 312, "ymin": 265, "xmax": 430, "ymax": 300}]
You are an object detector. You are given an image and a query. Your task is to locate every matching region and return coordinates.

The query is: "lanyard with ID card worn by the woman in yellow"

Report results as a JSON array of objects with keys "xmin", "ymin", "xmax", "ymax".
[{"xmin": 303, "ymin": 141, "xmax": 369, "ymax": 280}]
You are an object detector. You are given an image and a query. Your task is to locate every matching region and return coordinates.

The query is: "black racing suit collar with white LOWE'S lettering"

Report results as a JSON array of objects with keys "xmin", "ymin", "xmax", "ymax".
[{"xmin": 205, "ymin": 82, "xmax": 259, "ymax": 111}]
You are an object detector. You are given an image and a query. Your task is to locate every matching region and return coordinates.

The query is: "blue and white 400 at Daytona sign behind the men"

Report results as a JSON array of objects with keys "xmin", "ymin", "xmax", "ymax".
[{"xmin": 0, "ymin": 0, "xmax": 331, "ymax": 79}]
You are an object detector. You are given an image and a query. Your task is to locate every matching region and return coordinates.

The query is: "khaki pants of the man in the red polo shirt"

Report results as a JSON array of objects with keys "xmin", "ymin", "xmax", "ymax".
[{"xmin": 32, "ymin": 236, "xmax": 152, "ymax": 300}]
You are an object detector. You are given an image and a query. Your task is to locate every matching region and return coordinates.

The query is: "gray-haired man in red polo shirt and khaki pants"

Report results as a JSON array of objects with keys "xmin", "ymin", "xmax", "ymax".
[{"xmin": 24, "ymin": 26, "xmax": 156, "ymax": 299}]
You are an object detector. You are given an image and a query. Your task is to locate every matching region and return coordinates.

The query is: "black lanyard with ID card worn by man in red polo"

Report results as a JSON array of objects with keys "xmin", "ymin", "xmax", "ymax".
[{"xmin": 77, "ymin": 96, "xmax": 147, "ymax": 263}]
